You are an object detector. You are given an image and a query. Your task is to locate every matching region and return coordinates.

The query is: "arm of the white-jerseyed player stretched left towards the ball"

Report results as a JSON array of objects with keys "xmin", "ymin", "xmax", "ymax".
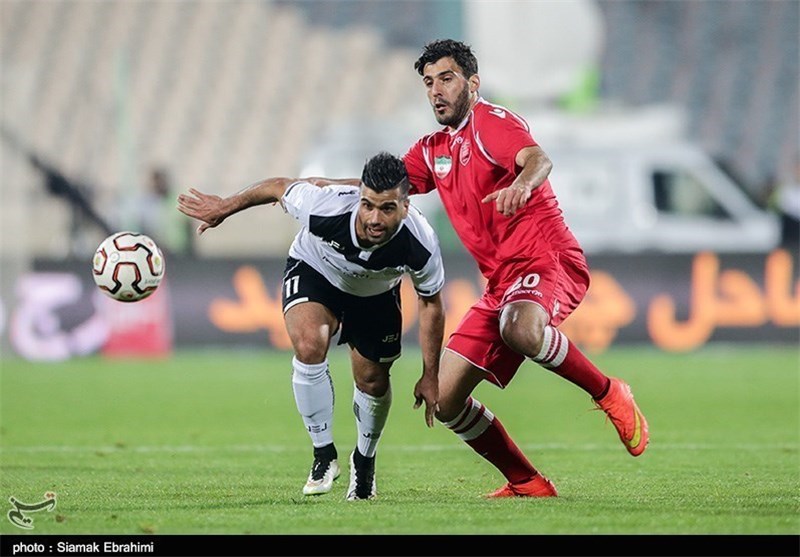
[{"xmin": 178, "ymin": 178, "xmax": 297, "ymax": 234}]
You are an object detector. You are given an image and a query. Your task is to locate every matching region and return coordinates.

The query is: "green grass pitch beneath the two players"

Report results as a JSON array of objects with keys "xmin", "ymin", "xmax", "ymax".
[{"xmin": 0, "ymin": 346, "xmax": 800, "ymax": 535}]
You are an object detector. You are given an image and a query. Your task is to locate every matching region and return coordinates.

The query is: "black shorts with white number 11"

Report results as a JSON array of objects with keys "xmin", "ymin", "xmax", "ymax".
[{"xmin": 281, "ymin": 257, "xmax": 403, "ymax": 363}]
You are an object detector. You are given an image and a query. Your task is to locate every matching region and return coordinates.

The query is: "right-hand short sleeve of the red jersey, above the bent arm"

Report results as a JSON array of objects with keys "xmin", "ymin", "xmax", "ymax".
[{"xmin": 477, "ymin": 106, "xmax": 538, "ymax": 172}]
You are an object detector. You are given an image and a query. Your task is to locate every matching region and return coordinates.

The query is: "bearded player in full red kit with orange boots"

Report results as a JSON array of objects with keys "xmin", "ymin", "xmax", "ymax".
[{"xmin": 404, "ymin": 39, "xmax": 648, "ymax": 497}]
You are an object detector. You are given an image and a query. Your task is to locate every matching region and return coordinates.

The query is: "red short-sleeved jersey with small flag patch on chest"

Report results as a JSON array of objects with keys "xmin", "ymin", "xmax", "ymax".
[{"xmin": 404, "ymin": 98, "xmax": 580, "ymax": 279}]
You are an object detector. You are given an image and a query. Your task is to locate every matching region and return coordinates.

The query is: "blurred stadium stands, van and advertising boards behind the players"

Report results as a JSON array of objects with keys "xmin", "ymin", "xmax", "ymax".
[{"xmin": 0, "ymin": 0, "xmax": 800, "ymax": 359}]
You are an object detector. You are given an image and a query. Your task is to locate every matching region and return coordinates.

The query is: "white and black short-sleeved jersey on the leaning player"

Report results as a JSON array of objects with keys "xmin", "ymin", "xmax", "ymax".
[{"xmin": 281, "ymin": 182, "xmax": 444, "ymax": 297}]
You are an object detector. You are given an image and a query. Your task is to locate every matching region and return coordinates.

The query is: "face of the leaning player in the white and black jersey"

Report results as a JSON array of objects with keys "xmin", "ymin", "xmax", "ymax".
[{"xmin": 356, "ymin": 185, "xmax": 408, "ymax": 247}]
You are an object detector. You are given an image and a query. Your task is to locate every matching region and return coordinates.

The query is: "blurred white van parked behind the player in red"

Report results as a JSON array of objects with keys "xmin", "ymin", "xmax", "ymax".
[{"xmin": 547, "ymin": 143, "xmax": 780, "ymax": 253}]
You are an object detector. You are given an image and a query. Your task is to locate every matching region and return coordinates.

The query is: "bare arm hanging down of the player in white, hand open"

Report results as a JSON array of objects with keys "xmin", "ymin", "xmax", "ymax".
[{"xmin": 414, "ymin": 292, "xmax": 444, "ymax": 427}]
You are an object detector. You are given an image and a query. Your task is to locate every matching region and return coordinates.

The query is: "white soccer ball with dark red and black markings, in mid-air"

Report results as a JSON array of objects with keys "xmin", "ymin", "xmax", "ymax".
[{"xmin": 92, "ymin": 232, "xmax": 164, "ymax": 302}]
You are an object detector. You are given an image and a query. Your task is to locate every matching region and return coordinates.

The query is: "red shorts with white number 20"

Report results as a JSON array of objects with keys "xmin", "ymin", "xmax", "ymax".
[{"xmin": 446, "ymin": 250, "xmax": 589, "ymax": 388}]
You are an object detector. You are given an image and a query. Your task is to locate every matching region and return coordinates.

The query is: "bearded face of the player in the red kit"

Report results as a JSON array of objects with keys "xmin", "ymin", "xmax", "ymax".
[{"xmin": 422, "ymin": 56, "xmax": 479, "ymax": 127}]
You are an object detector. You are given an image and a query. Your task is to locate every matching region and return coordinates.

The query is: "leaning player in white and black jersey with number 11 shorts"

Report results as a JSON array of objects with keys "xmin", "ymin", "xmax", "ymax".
[{"xmin": 178, "ymin": 153, "xmax": 444, "ymax": 500}]
